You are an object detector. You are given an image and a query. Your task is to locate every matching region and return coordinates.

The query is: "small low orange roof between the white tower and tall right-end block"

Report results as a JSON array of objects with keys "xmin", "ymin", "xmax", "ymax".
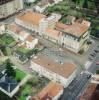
[{"xmin": 46, "ymin": 28, "xmax": 62, "ymax": 39}]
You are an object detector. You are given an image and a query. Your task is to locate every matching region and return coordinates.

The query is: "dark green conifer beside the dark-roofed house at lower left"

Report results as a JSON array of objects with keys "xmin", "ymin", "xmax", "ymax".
[{"xmin": 5, "ymin": 59, "xmax": 16, "ymax": 77}]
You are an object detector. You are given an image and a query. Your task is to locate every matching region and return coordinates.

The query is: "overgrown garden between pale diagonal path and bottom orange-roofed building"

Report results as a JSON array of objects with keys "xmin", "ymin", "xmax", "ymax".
[{"xmin": 16, "ymin": 75, "xmax": 49, "ymax": 100}]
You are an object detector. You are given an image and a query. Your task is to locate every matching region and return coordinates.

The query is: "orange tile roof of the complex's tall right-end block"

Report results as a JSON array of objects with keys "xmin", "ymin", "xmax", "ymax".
[{"xmin": 56, "ymin": 20, "xmax": 90, "ymax": 37}]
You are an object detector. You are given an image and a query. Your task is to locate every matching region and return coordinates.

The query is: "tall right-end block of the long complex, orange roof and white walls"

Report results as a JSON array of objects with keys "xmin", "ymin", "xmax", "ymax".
[{"xmin": 56, "ymin": 20, "xmax": 90, "ymax": 53}]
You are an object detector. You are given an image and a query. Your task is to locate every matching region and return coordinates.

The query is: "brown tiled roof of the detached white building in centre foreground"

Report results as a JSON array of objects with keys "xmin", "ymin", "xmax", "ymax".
[{"xmin": 33, "ymin": 55, "xmax": 77, "ymax": 78}]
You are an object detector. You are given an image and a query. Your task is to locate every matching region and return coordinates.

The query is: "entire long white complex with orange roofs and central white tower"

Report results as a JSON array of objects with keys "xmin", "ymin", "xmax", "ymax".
[{"xmin": 15, "ymin": 12, "xmax": 90, "ymax": 53}]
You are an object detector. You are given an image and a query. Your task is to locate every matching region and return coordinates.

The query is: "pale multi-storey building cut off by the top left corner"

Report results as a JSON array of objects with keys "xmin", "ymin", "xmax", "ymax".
[{"xmin": 0, "ymin": 0, "xmax": 23, "ymax": 19}]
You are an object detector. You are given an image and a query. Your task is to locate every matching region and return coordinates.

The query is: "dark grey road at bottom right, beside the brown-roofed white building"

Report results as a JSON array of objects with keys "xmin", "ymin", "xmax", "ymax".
[{"xmin": 60, "ymin": 73, "xmax": 90, "ymax": 100}]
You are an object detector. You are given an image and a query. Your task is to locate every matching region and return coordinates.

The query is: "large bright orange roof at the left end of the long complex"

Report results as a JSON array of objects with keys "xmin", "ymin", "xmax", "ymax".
[{"xmin": 17, "ymin": 11, "xmax": 45, "ymax": 25}]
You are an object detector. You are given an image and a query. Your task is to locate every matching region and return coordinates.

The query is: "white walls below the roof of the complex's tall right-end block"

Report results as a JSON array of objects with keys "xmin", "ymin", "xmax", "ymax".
[{"xmin": 60, "ymin": 31, "xmax": 90, "ymax": 53}]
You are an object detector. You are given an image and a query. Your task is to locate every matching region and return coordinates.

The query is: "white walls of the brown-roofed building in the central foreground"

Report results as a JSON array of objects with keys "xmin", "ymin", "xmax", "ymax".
[{"xmin": 31, "ymin": 57, "xmax": 78, "ymax": 87}]
